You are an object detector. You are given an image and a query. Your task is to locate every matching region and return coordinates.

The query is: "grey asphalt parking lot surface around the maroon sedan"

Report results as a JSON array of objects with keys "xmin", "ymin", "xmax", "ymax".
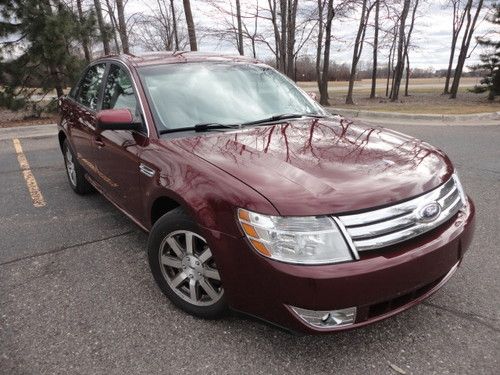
[{"xmin": 0, "ymin": 126, "xmax": 500, "ymax": 374}]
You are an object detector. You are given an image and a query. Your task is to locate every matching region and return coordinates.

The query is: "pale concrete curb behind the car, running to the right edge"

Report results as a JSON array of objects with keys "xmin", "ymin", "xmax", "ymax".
[{"xmin": 327, "ymin": 107, "xmax": 500, "ymax": 125}]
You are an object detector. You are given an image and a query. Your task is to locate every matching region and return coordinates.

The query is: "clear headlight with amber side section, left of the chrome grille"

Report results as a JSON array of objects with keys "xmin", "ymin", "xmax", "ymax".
[{"xmin": 238, "ymin": 208, "xmax": 353, "ymax": 264}]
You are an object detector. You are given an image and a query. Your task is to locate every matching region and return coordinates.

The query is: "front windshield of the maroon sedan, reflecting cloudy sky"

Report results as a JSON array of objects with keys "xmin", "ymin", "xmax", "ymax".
[{"xmin": 139, "ymin": 62, "xmax": 324, "ymax": 130}]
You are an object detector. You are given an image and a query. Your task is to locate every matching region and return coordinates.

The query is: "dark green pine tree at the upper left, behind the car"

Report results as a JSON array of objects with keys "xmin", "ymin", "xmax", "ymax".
[{"xmin": 0, "ymin": 0, "xmax": 93, "ymax": 111}]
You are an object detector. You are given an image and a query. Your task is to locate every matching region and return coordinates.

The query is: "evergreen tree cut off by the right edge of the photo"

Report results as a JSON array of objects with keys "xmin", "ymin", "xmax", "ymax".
[{"xmin": 472, "ymin": 3, "xmax": 500, "ymax": 100}]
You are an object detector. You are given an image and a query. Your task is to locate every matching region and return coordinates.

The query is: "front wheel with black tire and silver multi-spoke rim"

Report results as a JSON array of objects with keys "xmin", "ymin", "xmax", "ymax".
[{"xmin": 148, "ymin": 208, "xmax": 228, "ymax": 319}]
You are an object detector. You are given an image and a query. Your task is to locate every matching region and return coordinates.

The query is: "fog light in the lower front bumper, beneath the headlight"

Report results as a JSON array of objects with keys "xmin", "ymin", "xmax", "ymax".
[{"xmin": 290, "ymin": 306, "xmax": 356, "ymax": 328}]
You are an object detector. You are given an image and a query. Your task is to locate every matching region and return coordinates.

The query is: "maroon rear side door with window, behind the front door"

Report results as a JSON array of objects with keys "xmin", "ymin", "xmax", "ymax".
[{"xmin": 66, "ymin": 63, "xmax": 106, "ymax": 176}]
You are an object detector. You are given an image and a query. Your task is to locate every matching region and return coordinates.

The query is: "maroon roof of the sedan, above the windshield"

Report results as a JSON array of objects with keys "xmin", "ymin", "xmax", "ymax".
[{"xmin": 99, "ymin": 51, "xmax": 260, "ymax": 67}]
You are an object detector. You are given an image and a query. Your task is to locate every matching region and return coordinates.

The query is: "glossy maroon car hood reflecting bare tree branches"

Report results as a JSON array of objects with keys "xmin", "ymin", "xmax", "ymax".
[{"xmin": 172, "ymin": 117, "xmax": 453, "ymax": 215}]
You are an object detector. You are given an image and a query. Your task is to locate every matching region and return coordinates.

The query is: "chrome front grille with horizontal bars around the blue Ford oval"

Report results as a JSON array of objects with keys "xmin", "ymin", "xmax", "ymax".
[{"xmin": 338, "ymin": 175, "xmax": 465, "ymax": 252}]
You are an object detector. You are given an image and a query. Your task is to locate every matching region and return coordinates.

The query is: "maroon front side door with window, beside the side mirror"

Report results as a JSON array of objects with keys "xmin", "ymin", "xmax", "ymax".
[{"xmin": 93, "ymin": 62, "xmax": 148, "ymax": 220}]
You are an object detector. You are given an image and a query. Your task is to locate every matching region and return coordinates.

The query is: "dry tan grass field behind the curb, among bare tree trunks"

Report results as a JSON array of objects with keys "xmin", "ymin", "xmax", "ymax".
[{"xmin": 298, "ymin": 77, "xmax": 500, "ymax": 114}]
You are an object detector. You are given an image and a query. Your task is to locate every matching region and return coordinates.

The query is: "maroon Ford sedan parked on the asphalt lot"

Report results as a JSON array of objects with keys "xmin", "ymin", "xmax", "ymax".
[{"xmin": 59, "ymin": 53, "xmax": 474, "ymax": 333}]
